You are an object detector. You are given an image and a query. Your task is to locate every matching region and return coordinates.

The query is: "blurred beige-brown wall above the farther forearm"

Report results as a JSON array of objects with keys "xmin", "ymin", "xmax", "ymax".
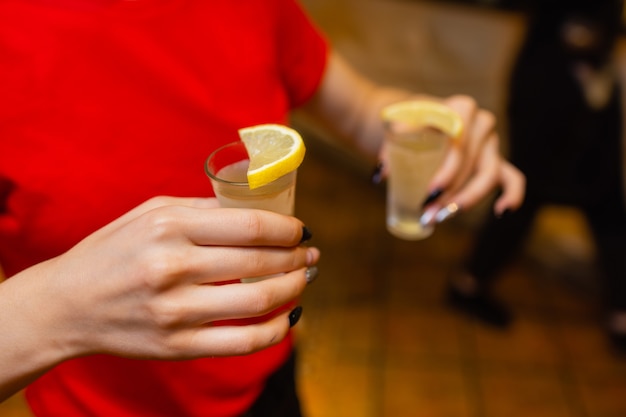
[{"xmin": 301, "ymin": 0, "xmax": 524, "ymax": 147}]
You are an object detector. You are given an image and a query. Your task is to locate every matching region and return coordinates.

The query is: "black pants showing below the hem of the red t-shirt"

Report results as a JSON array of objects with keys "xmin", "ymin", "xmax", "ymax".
[{"xmin": 241, "ymin": 353, "xmax": 302, "ymax": 417}]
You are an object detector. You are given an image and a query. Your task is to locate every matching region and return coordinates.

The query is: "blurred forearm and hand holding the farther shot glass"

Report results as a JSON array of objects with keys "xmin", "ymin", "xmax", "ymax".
[{"xmin": 303, "ymin": 51, "xmax": 525, "ymax": 223}]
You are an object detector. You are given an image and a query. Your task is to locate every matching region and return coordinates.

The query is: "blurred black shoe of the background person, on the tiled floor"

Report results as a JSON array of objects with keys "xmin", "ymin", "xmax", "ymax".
[{"xmin": 446, "ymin": 285, "xmax": 513, "ymax": 330}]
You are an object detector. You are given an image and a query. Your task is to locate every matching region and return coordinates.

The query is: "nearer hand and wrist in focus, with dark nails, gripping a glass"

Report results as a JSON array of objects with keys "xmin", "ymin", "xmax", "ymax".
[{"xmin": 0, "ymin": 197, "xmax": 319, "ymax": 398}]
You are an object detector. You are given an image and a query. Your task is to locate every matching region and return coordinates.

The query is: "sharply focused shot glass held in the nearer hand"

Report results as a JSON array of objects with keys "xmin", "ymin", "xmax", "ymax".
[{"xmin": 204, "ymin": 141, "xmax": 297, "ymax": 216}]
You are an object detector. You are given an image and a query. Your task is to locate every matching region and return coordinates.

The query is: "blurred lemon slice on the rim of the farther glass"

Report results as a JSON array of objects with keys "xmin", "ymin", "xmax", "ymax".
[{"xmin": 381, "ymin": 100, "xmax": 463, "ymax": 140}]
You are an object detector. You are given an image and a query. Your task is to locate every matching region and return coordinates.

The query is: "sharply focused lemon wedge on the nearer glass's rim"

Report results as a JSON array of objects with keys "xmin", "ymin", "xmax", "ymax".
[{"xmin": 239, "ymin": 124, "xmax": 305, "ymax": 189}]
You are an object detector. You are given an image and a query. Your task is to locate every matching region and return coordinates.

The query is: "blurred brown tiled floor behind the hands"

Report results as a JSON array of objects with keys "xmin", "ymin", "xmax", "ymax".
[{"xmin": 0, "ymin": 132, "xmax": 626, "ymax": 417}]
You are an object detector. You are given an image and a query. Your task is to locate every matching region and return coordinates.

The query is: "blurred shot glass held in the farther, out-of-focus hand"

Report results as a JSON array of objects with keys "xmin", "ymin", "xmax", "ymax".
[{"xmin": 384, "ymin": 119, "xmax": 451, "ymax": 240}]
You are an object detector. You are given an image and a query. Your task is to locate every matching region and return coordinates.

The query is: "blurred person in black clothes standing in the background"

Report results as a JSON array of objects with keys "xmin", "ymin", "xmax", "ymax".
[{"xmin": 447, "ymin": 0, "xmax": 626, "ymax": 353}]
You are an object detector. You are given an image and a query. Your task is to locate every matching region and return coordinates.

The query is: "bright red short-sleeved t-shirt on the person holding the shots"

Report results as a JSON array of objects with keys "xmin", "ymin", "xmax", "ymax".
[{"xmin": 0, "ymin": 0, "xmax": 327, "ymax": 417}]
